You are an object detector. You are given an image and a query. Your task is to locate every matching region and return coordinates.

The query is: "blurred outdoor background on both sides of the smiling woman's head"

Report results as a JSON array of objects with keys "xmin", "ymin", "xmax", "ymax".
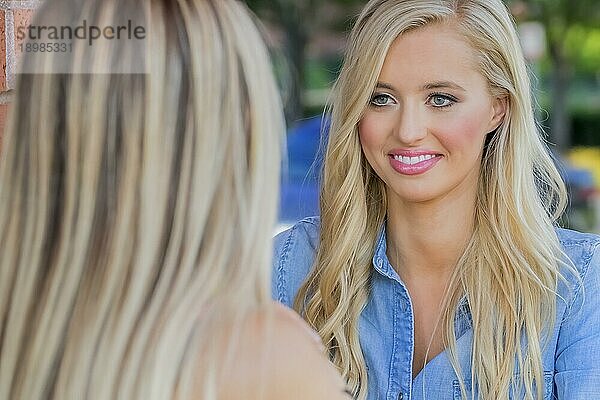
[{"xmin": 246, "ymin": 0, "xmax": 600, "ymax": 233}]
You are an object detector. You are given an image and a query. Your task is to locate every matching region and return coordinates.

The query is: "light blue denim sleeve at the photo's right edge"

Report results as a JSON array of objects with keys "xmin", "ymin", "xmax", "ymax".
[{"xmin": 554, "ymin": 235, "xmax": 600, "ymax": 400}]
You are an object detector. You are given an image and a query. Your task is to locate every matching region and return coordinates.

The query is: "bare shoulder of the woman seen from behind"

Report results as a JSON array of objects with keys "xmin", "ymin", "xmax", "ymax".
[{"xmin": 221, "ymin": 304, "xmax": 350, "ymax": 400}]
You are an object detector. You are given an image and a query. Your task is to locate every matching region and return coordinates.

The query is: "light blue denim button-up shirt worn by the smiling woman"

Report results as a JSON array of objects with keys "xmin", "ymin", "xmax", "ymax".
[{"xmin": 272, "ymin": 218, "xmax": 600, "ymax": 400}]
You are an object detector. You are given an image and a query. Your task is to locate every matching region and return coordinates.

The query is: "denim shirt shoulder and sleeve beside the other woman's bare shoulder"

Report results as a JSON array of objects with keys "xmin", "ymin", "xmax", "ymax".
[{"xmin": 271, "ymin": 217, "xmax": 319, "ymax": 307}]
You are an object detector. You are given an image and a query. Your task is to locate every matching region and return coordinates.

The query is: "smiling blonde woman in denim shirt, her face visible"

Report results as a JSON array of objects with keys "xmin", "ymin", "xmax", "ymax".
[{"xmin": 272, "ymin": 0, "xmax": 600, "ymax": 400}]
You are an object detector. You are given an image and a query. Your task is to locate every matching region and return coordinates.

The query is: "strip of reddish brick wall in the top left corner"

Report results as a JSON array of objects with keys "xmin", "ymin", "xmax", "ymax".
[{"xmin": 0, "ymin": 0, "xmax": 40, "ymax": 140}]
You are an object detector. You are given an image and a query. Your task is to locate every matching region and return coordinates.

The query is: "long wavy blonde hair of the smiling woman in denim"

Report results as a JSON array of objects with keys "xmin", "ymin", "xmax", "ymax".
[{"xmin": 295, "ymin": 0, "xmax": 574, "ymax": 399}]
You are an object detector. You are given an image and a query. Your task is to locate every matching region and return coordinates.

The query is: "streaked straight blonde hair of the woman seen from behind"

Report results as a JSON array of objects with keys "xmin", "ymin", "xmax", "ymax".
[{"xmin": 0, "ymin": 0, "xmax": 284, "ymax": 400}]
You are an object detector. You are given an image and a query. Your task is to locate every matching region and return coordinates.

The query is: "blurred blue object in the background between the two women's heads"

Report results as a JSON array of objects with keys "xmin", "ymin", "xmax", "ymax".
[{"xmin": 279, "ymin": 116, "xmax": 329, "ymax": 224}]
